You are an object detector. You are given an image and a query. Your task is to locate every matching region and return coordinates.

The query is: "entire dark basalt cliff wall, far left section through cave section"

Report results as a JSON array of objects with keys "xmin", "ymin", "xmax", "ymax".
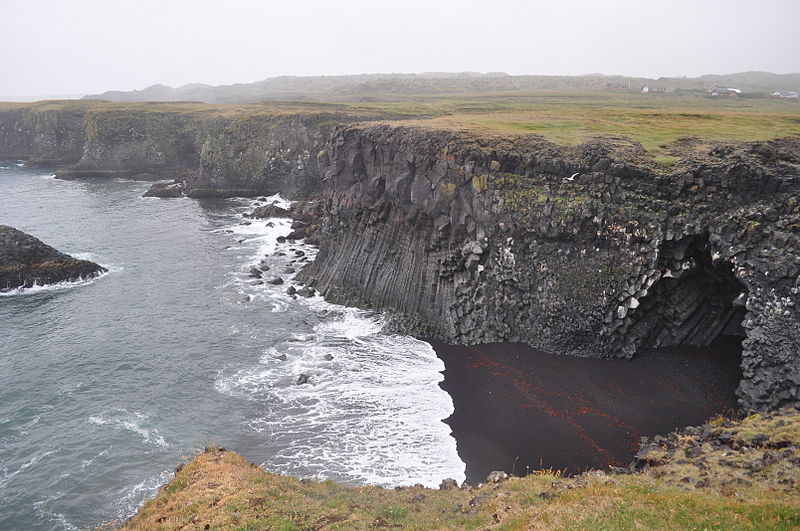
[{"xmin": 0, "ymin": 104, "xmax": 800, "ymax": 409}]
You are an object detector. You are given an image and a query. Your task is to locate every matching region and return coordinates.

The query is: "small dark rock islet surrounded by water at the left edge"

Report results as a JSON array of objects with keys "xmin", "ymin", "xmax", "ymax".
[{"xmin": 0, "ymin": 225, "xmax": 106, "ymax": 291}]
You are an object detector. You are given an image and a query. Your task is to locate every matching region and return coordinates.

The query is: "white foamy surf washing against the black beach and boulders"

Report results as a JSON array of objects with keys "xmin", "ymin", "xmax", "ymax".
[{"xmin": 214, "ymin": 194, "xmax": 465, "ymax": 487}]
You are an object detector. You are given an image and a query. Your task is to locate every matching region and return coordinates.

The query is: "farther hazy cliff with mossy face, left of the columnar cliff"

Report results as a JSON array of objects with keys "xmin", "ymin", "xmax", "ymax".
[{"xmin": 0, "ymin": 102, "xmax": 375, "ymax": 197}]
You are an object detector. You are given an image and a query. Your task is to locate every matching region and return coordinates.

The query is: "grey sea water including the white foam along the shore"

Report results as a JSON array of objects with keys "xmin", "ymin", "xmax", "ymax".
[{"xmin": 0, "ymin": 161, "xmax": 465, "ymax": 529}]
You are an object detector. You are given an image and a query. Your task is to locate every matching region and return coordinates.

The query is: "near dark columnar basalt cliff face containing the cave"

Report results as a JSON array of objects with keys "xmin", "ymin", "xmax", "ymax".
[{"xmin": 302, "ymin": 126, "xmax": 800, "ymax": 408}]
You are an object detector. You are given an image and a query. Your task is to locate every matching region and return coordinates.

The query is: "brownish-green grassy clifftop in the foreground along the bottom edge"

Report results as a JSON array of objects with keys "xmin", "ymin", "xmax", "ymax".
[{"xmin": 124, "ymin": 410, "xmax": 800, "ymax": 530}]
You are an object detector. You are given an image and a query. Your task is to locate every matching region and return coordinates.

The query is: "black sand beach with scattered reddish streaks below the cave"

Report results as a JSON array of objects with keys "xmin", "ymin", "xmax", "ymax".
[{"xmin": 430, "ymin": 336, "xmax": 741, "ymax": 484}]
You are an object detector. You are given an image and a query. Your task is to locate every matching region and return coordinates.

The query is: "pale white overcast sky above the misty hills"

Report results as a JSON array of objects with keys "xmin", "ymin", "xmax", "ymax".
[{"xmin": 0, "ymin": 0, "xmax": 800, "ymax": 99}]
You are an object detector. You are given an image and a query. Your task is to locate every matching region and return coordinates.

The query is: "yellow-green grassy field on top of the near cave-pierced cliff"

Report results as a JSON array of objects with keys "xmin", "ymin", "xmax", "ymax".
[{"xmin": 352, "ymin": 92, "xmax": 800, "ymax": 152}]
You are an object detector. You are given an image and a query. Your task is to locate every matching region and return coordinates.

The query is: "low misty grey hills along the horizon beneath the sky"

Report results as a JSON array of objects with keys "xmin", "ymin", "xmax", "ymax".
[{"xmin": 85, "ymin": 72, "xmax": 800, "ymax": 103}]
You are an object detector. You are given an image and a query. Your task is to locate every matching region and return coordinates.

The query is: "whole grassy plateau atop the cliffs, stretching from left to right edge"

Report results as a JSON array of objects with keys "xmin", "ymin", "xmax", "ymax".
[{"xmin": 0, "ymin": 91, "xmax": 800, "ymax": 154}]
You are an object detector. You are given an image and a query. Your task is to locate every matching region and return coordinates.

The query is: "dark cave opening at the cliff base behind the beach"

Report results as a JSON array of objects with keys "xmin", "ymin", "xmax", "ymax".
[{"xmin": 627, "ymin": 235, "xmax": 747, "ymax": 357}]
